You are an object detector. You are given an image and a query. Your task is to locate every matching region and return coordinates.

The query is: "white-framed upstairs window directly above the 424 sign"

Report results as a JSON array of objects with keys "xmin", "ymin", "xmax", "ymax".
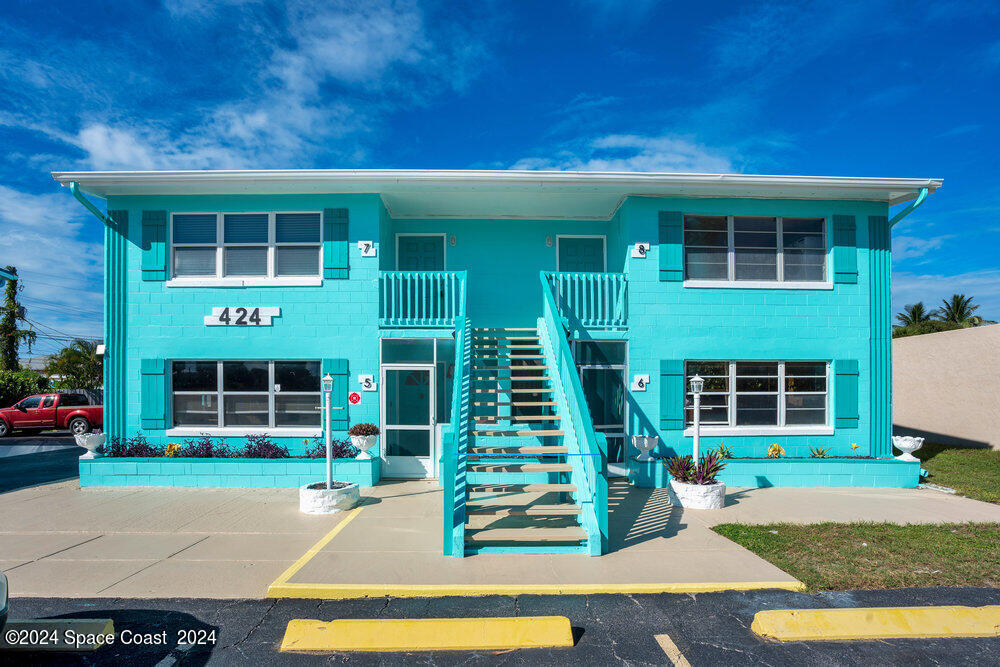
[{"xmin": 171, "ymin": 212, "xmax": 322, "ymax": 278}]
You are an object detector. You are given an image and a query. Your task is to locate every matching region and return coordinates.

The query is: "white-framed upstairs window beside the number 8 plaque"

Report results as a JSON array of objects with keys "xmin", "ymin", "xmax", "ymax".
[{"xmin": 684, "ymin": 215, "xmax": 829, "ymax": 283}]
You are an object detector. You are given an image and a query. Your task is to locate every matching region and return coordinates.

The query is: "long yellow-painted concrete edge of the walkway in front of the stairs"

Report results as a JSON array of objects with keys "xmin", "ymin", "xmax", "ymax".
[{"xmin": 267, "ymin": 579, "xmax": 805, "ymax": 600}]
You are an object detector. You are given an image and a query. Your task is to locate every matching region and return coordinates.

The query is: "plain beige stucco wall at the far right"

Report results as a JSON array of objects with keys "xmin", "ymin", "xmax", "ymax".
[{"xmin": 892, "ymin": 325, "xmax": 1000, "ymax": 449}]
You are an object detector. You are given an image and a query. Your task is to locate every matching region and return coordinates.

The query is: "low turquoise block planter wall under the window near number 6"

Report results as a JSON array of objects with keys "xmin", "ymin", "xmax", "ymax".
[{"xmin": 628, "ymin": 457, "xmax": 920, "ymax": 488}]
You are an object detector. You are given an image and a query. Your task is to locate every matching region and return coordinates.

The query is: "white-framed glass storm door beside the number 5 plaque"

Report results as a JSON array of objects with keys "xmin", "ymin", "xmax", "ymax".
[{"xmin": 382, "ymin": 366, "xmax": 437, "ymax": 477}]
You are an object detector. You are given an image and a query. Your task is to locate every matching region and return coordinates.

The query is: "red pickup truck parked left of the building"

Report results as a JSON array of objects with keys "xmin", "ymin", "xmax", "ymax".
[{"xmin": 0, "ymin": 394, "xmax": 104, "ymax": 438}]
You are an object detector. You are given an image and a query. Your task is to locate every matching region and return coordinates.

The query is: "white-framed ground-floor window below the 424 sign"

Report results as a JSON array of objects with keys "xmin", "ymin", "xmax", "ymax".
[{"xmin": 171, "ymin": 361, "xmax": 321, "ymax": 427}]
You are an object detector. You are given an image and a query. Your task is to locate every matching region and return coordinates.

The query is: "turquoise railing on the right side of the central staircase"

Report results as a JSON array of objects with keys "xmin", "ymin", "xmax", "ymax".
[{"xmin": 538, "ymin": 271, "xmax": 608, "ymax": 556}]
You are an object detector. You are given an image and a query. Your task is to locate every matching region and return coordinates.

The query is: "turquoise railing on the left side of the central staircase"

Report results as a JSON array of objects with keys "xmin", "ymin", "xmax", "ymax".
[{"xmin": 438, "ymin": 272, "xmax": 472, "ymax": 558}]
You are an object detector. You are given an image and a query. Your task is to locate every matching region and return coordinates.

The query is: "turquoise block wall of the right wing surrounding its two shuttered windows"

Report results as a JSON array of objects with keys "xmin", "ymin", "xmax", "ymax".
[{"xmin": 616, "ymin": 197, "xmax": 892, "ymax": 457}]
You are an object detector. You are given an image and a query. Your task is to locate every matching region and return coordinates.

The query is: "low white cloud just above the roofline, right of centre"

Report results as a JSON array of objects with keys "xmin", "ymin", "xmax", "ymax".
[{"xmin": 510, "ymin": 134, "xmax": 735, "ymax": 173}]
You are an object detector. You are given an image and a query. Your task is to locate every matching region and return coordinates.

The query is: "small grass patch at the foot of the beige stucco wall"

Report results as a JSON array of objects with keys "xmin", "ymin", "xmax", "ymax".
[{"xmin": 914, "ymin": 443, "xmax": 1000, "ymax": 504}]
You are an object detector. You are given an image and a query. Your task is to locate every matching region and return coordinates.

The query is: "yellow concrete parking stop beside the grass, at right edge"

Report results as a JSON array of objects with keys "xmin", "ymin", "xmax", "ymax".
[{"xmin": 750, "ymin": 605, "xmax": 1000, "ymax": 642}]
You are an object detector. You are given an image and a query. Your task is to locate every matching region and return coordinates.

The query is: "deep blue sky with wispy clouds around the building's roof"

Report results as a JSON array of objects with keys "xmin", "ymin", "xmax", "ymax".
[{"xmin": 0, "ymin": 0, "xmax": 1000, "ymax": 353}]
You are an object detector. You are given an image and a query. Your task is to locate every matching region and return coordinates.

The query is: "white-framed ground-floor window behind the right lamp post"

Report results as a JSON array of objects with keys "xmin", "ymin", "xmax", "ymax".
[{"xmin": 684, "ymin": 361, "xmax": 830, "ymax": 429}]
